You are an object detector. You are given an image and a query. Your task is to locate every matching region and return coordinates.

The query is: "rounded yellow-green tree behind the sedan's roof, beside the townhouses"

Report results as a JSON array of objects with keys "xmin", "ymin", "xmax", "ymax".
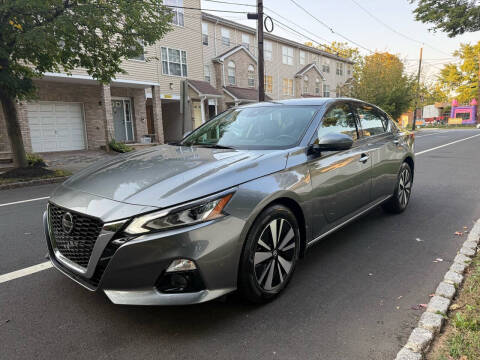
[{"xmin": 352, "ymin": 52, "xmax": 416, "ymax": 119}]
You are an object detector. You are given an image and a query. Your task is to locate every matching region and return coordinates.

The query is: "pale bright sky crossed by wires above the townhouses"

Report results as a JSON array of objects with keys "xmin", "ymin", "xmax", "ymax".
[{"xmin": 202, "ymin": 0, "xmax": 480, "ymax": 80}]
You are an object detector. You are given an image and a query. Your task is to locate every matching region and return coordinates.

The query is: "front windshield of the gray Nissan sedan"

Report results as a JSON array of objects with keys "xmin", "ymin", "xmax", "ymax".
[{"xmin": 180, "ymin": 106, "xmax": 318, "ymax": 149}]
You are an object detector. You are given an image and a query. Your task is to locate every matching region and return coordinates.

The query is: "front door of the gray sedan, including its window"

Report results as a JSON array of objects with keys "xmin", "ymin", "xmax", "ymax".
[{"xmin": 308, "ymin": 103, "xmax": 372, "ymax": 237}]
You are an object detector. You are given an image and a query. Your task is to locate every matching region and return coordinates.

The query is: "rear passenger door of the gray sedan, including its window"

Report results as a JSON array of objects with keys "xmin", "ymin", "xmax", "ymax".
[{"xmin": 354, "ymin": 103, "xmax": 402, "ymax": 202}]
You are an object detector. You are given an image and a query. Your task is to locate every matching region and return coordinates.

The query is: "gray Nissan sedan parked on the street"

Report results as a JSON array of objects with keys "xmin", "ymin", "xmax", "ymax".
[{"xmin": 44, "ymin": 98, "xmax": 414, "ymax": 305}]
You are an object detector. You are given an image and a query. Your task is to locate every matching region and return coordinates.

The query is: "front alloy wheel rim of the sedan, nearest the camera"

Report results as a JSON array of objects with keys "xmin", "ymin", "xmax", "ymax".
[{"xmin": 254, "ymin": 218, "xmax": 296, "ymax": 291}]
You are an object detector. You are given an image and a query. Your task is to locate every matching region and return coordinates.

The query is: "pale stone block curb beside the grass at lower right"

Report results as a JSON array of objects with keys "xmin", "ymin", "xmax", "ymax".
[{"xmin": 395, "ymin": 219, "xmax": 480, "ymax": 360}]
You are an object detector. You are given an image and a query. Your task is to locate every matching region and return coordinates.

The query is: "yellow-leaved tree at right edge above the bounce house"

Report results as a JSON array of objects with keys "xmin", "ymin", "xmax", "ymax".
[{"xmin": 438, "ymin": 41, "xmax": 480, "ymax": 104}]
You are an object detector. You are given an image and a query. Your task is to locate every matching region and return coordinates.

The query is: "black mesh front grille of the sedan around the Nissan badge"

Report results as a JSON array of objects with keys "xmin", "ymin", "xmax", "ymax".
[{"xmin": 48, "ymin": 204, "xmax": 103, "ymax": 268}]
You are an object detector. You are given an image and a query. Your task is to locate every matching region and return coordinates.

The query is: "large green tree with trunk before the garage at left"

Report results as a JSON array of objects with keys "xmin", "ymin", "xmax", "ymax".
[{"xmin": 0, "ymin": 0, "xmax": 173, "ymax": 167}]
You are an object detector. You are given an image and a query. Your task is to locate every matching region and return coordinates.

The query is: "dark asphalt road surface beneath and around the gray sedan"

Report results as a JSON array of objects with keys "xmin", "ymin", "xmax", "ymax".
[{"xmin": 0, "ymin": 130, "xmax": 480, "ymax": 360}]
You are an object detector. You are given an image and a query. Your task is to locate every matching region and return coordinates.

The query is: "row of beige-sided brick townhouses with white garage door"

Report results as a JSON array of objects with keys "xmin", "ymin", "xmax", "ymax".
[{"xmin": 0, "ymin": 0, "xmax": 352, "ymax": 157}]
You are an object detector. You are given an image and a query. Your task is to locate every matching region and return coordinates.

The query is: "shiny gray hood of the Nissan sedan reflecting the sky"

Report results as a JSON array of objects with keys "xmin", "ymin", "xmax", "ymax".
[{"xmin": 58, "ymin": 145, "xmax": 288, "ymax": 208}]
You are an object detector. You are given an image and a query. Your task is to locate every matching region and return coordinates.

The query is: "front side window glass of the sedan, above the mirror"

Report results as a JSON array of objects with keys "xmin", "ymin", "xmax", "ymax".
[{"xmin": 318, "ymin": 104, "xmax": 358, "ymax": 140}]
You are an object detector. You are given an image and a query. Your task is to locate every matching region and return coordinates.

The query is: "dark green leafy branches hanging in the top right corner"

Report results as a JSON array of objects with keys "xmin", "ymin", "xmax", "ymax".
[{"xmin": 411, "ymin": 0, "xmax": 480, "ymax": 37}]
